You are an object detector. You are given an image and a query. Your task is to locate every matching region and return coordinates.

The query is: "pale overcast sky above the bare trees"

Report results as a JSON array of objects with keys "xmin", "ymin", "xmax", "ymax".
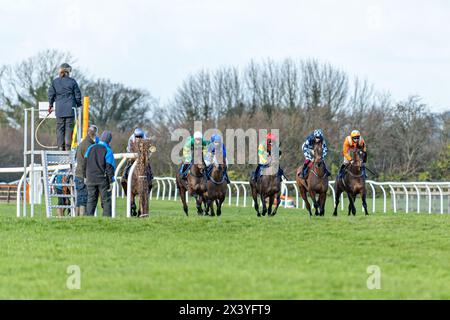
[{"xmin": 0, "ymin": 0, "xmax": 450, "ymax": 111}]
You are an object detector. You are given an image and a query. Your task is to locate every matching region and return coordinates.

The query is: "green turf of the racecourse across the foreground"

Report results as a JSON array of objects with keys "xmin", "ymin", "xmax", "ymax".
[{"xmin": 0, "ymin": 200, "xmax": 450, "ymax": 299}]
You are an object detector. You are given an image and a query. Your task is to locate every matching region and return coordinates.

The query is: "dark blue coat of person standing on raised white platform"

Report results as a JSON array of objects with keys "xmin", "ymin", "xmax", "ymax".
[{"xmin": 48, "ymin": 76, "xmax": 82, "ymax": 118}]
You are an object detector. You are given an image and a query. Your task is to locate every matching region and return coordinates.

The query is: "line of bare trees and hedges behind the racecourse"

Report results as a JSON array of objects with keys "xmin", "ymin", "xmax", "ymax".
[{"xmin": 0, "ymin": 51, "xmax": 450, "ymax": 181}]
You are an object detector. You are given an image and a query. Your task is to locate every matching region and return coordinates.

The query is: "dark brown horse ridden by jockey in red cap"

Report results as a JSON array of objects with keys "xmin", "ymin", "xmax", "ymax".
[{"xmin": 250, "ymin": 161, "xmax": 281, "ymax": 217}]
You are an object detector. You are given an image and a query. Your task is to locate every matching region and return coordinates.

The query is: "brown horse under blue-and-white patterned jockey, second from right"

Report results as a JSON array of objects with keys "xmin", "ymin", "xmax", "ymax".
[{"xmin": 296, "ymin": 143, "xmax": 328, "ymax": 217}]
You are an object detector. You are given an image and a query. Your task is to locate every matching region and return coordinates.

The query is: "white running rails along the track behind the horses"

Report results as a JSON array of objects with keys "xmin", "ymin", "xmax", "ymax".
[{"xmin": 0, "ymin": 159, "xmax": 450, "ymax": 217}]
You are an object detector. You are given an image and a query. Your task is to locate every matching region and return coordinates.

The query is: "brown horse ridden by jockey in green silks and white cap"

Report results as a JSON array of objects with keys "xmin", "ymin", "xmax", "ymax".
[{"xmin": 176, "ymin": 148, "xmax": 206, "ymax": 216}]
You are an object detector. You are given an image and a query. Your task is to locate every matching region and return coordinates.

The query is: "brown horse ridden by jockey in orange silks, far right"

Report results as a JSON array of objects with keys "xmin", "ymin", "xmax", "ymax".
[{"xmin": 333, "ymin": 150, "xmax": 369, "ymax": 216}]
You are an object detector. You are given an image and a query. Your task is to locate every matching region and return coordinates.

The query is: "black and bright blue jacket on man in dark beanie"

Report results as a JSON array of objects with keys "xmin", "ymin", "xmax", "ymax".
[{"xmin": 84, "ymin": 141, "xmax": 116, "ymax": 184}]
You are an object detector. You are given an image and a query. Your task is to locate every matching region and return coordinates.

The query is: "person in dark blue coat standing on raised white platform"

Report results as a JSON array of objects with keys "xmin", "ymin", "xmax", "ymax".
[{"xmin": 48, "ymin": 63, "xmax": 82, "ymax": 151}]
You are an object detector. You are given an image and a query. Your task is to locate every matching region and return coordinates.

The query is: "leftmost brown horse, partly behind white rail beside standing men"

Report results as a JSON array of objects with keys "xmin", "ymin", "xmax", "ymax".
[{"xmin": 122, "ymin": 138, "xmax": 156, "ymax": 218}]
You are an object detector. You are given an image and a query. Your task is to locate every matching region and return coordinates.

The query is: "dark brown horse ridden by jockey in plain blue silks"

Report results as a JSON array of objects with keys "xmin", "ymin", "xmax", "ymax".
[{"xmin": 205, "ymin": 157, "xmax": 228, "ymax": 216}]
